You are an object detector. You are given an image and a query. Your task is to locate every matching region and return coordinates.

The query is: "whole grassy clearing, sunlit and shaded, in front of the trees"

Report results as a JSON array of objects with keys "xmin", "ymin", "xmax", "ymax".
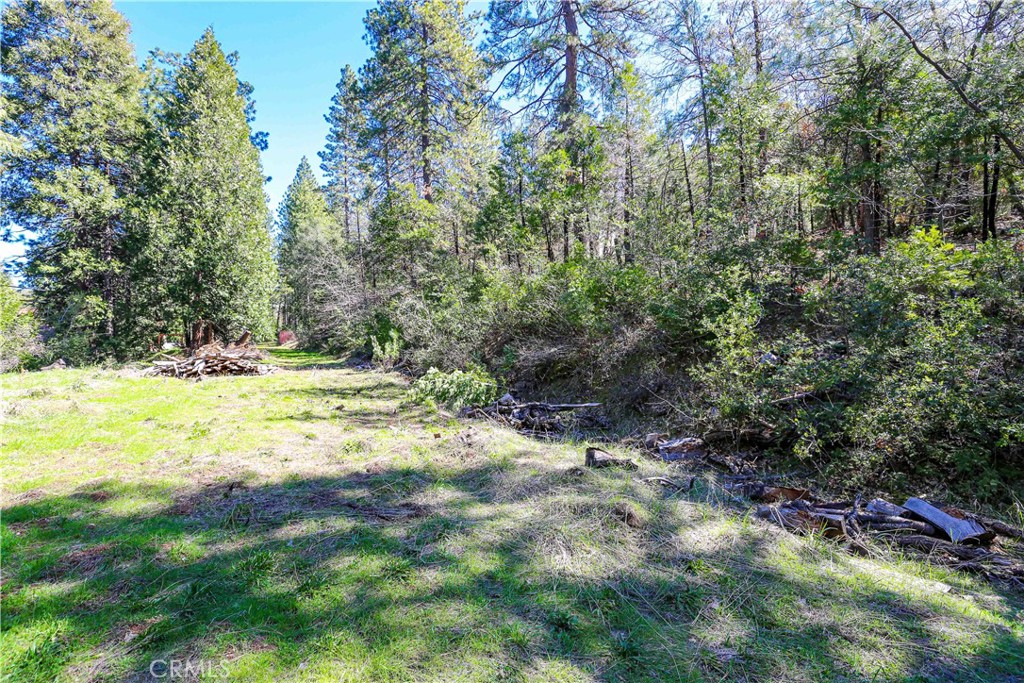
[{"xmin": 0, "ymin": 351, "xmax": 1024, "ymax": 683}]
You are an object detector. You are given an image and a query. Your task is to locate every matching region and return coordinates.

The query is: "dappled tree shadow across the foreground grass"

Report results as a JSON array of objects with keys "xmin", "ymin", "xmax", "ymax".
[{"xmin": 2, "ymin": 461, "xmax": 1024, "ymax": 681}]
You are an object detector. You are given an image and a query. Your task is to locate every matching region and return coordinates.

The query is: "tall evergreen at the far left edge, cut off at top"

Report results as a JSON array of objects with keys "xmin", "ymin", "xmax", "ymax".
[{"xmin": 2, "ymin": 0, "xmax": 142, "ymax": 355}]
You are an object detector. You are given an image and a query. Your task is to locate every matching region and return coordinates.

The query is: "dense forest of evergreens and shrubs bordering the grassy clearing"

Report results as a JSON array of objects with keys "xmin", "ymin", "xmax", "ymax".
[{"xmin": 6, "ymin": 0, "xmax": 1024, "ymax": 499}]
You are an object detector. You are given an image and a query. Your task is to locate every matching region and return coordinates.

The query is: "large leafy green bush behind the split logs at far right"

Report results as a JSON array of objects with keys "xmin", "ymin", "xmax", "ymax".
[{"xmin": 690, "ymin": 230, "xmax": 1024, "ymax": 497}]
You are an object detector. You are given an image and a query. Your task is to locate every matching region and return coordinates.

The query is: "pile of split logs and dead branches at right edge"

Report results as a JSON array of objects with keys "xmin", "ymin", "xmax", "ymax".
[{"xmin": 743, "ymin": 493, "xmax": 1024, "ymax": 587}]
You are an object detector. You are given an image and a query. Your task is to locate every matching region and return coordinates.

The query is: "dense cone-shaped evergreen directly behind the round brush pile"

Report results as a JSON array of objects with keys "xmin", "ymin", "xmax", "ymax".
[{"xmin": 146, "ymin": 29, "xmax": 276, "ymax": 344}]
